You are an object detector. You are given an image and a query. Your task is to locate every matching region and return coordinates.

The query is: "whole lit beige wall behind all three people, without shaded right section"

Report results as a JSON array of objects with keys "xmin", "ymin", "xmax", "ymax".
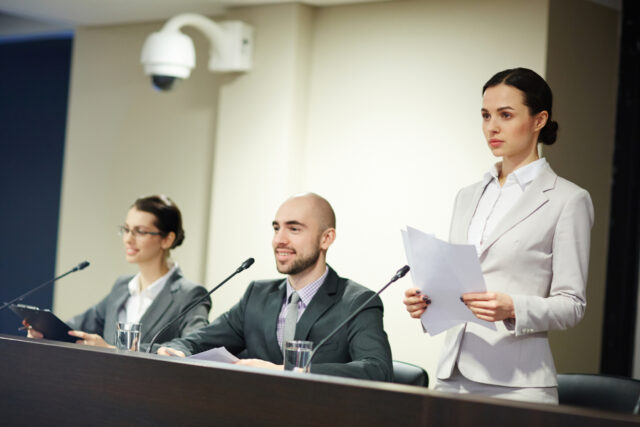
[{"xmin": 55, "ymin": 0, "xmax": 616, "ymax": 382}]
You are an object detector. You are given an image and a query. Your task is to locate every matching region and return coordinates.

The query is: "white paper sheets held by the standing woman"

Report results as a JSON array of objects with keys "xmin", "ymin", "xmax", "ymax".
[{"xmin": 401, "ymin": 227, "xmax": 496, "ymax": 335}]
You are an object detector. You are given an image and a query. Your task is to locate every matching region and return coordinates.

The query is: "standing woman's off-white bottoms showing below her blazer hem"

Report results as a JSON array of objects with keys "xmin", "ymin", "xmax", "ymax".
[{"xmin": 433, "ymin": 366, "xmax": 558, "ymax": 405}]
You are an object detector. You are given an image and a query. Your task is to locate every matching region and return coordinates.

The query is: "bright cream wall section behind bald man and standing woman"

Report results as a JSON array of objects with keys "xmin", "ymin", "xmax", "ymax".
[{"xmin": 207, "ymin": 0, "xmax": 548, "ymax": 382}]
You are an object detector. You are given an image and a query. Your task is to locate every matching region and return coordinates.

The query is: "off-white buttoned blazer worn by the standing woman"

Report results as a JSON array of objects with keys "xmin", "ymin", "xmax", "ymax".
[{"xmin": 437, "ymin": 164, "xmax": 593, "ymax": 387}]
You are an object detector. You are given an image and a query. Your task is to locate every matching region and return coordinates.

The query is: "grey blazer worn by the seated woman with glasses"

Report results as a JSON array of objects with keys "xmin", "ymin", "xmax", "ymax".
[{"xmin": 67, "ymin": 268, "xmax": 211, "ymax": 345}]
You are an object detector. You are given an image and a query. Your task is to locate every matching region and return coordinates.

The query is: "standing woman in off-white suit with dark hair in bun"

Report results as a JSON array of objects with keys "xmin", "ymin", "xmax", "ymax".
[{"xmin": 403, "ymin": 68, "xmax": 593, "ymax": 403}]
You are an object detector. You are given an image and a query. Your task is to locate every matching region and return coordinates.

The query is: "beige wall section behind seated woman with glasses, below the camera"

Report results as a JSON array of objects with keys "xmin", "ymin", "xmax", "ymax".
[{"xmin": 54, "ymin": 24, "xmax": 219, "ymax": 318}]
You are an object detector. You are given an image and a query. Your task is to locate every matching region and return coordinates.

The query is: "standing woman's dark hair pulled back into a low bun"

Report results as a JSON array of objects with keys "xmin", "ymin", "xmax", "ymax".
[{"xmin": 482, "ymin": 68, "xmax": 558, "ymax": 145}]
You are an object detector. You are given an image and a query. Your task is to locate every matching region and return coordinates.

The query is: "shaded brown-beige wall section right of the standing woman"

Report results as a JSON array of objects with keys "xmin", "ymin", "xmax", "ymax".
[{"xmin": 544, "ymin": 0, "xmax": 619, "ymax": 372}]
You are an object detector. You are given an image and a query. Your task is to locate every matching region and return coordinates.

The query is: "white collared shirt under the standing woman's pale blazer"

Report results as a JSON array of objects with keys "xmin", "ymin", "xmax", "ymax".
[{"xmin": 468, "ymin": 158, "xmax": 547, "ymax": 255}]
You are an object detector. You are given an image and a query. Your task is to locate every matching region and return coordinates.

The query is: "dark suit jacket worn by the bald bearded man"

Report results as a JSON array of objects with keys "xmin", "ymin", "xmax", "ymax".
[{"xmin": 167, "ymin": 268, "xmax": 392, "ymax": 381}]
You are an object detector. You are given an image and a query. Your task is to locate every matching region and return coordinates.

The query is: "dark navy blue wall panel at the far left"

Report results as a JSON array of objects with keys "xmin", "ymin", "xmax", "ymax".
[{"xmin": 0, "ymin": 35, "xmax": 73, "ymax": 334}]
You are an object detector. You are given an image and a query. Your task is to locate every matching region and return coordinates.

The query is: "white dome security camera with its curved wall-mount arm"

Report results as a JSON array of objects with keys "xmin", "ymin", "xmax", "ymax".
[{"xmin": 140, "ymin": 13, "xmax": 253, "ymax": 91}]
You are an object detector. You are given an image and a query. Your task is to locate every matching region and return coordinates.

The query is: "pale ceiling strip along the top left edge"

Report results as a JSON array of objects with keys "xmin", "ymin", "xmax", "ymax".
[{"xmin": 0, "ymin": 0, "xmax": 379, "ymax": 29}]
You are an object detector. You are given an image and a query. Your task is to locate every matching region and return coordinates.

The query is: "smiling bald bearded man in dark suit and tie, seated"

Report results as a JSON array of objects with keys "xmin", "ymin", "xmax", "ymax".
[{"xmin": 158, "ymin": 193, "xmax": 392, "ymax": 381}]
